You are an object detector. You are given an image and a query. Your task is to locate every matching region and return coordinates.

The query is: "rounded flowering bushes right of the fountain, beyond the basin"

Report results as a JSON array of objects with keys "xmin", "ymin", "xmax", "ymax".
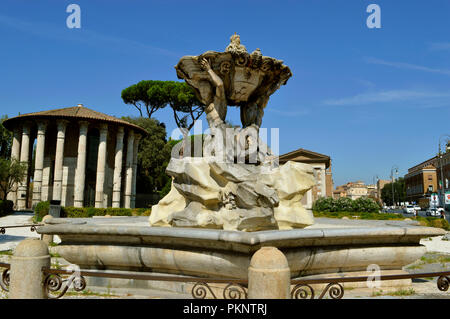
[{"xmin": 312, "ymin": 197, "xmax": 381, "ymax": 213}]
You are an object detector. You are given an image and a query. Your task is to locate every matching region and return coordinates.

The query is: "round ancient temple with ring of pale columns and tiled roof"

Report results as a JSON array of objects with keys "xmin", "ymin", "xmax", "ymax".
[{"xmin": 3, "ymin": 104, "xmax": 147, "ymax": 210}]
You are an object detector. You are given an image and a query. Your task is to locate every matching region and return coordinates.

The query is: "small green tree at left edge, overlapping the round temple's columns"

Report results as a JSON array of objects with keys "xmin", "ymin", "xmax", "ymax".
[{"xmin": 0, "ymin": 157, "xmax": 28, "ymax": 200}]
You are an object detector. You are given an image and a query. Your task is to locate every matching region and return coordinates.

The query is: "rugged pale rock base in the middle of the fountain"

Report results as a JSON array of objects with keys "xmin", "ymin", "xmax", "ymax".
[{"xmin": 149, "ymin": 157, "xmax": 315, "ymax": 231}]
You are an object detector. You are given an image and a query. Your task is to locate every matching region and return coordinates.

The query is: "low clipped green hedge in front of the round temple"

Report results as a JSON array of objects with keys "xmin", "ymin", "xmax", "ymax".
[{"xmin": 34, "ymin": 202, "xmax": 151, "ymax": 222}]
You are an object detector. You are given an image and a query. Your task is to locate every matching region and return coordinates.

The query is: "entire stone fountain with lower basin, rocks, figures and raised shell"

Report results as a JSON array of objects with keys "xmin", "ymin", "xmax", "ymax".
[{"xmin": 37, "ymin": 35, "xmax": 444, "ymax": 292}]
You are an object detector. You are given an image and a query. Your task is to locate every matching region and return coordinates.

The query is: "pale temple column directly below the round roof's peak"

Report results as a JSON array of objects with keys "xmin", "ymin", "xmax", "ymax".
[{"xmin": 73, "ymin": 121, "xmax": 89, "ymax": 207}]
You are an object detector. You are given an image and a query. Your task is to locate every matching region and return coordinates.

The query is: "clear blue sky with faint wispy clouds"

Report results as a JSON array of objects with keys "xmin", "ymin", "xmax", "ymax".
[{"xmin": 0, "ymin": 0, "xmax": 450, "ymax": 185}]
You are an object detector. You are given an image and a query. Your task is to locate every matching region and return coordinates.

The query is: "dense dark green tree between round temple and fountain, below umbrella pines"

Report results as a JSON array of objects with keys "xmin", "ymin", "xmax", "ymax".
[{"xmin": 122, "ymin": 117, "xmax": 172, "ymax": 194}]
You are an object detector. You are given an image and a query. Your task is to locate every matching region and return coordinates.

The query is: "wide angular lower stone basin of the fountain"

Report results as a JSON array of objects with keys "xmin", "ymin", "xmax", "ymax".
[{"xmin": 37, "ymin": 217, "xmax": 445, "ymax": 279}]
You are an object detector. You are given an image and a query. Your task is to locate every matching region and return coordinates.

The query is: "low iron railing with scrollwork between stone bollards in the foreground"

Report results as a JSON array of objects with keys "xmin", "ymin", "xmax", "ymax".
[{"xmin": 0, "ymin": 263, "xmax": 450, "ymax": 299}]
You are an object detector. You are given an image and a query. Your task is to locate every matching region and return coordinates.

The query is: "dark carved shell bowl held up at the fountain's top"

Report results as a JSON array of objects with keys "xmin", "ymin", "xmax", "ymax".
[{"xmin": 175, "ymin": 50, "xmax": 292, "ymax": 106}]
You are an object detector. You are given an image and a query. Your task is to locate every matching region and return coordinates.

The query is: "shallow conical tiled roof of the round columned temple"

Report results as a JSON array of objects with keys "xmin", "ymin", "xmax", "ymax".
[{"xmin": 3, "ymin": 104, "xmax": 147, "ymax": 134}]
